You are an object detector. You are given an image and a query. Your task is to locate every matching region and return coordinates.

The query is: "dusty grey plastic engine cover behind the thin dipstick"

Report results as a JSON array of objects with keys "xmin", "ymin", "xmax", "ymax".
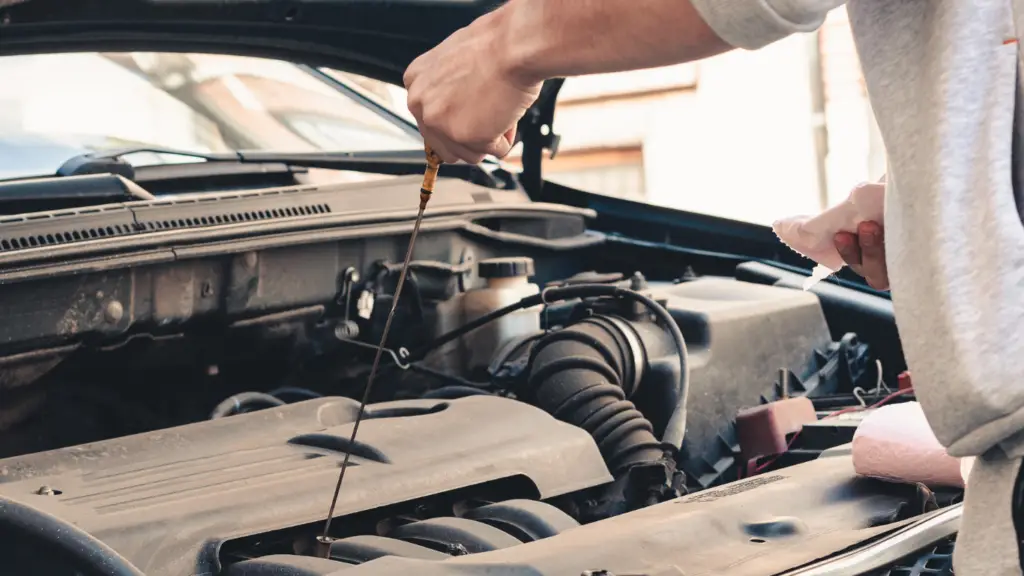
[{"xmin": 0, "ymin": 397, "xmax": 611, "ymax": 576}]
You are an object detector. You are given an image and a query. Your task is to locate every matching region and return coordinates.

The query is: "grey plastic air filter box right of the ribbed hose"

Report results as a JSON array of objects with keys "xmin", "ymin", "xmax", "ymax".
[{"xmin": 652, "ymin": 278, "xmax": 831, "ymax": 488}]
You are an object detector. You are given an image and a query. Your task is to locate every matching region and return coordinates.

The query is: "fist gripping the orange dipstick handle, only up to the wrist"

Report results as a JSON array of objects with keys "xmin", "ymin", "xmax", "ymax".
[{"xmin": 404, "ymin": 13, "xmax": 541, "ymax": 164}]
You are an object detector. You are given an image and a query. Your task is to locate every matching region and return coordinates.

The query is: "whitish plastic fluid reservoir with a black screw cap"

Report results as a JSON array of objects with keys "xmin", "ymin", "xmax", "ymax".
[{"xmin": 462, "ymin": 256, "xmax": 544, "ymax": 373}]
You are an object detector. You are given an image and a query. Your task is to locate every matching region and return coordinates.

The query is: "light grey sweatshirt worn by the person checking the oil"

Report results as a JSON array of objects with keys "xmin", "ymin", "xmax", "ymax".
[{"xmin": 692, "ymin": 0, "xmax": 1024, "ymax": 565}]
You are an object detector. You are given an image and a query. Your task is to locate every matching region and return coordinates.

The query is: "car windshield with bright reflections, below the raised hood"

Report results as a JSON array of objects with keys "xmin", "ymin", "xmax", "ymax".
[{"xmin": 0, "ymin": 52, "xmax": 422, "ymax": 178}]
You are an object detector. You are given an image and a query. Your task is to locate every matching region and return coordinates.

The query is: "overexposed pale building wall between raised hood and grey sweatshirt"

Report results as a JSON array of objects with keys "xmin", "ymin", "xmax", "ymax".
[{"xmin": 348, "ymin": 9, "xmax": 885, "ymax": 223}]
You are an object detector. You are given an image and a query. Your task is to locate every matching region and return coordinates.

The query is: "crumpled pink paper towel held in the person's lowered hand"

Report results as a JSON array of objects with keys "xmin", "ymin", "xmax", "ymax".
[{"xmin": 772, "ymin": 183, "xmax": 886, "ymax": 290}]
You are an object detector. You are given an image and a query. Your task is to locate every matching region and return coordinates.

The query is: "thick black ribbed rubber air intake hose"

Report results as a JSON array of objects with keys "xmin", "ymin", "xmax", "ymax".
[{"xmin": 525, "ymin": 316, "xmax": 665, "ymax": 476}]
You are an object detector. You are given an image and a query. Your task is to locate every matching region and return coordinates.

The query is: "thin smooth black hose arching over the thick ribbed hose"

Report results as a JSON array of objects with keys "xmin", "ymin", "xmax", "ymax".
[{"xmin": 410, "ymin": 284, "xmax": 690, "ymax": 450}]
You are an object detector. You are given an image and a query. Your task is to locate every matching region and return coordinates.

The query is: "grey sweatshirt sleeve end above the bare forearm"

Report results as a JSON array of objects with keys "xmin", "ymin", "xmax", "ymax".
[{"xmin": 690, "ymin": 0, "xmax": 846, "ymax": 50}]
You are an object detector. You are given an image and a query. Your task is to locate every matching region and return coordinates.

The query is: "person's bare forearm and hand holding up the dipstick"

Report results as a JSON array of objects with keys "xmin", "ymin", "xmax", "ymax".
[{"xmin": 404, "ymin": 0, "xmax": 731, "ymax": 163}]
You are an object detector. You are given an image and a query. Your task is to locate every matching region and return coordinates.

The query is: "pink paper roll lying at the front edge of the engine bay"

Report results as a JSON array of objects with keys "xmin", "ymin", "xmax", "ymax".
[{"xmin": 853, "ymin": 402, "xmax": 972, "ymax": 488}]
